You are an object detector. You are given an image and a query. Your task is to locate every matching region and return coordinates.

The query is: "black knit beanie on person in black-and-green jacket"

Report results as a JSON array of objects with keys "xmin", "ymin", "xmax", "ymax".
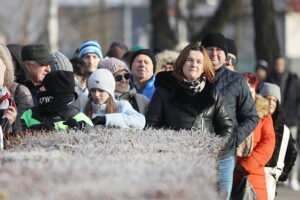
[{"xmin": 43, "ymin": 70, "xmax": 75, "ymax": 94}]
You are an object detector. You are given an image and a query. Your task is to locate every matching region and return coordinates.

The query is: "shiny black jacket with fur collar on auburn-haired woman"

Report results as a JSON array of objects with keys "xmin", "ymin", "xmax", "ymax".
[{"xmin": 146, "ymin": 72, "xmax": 233, "ymax": 139}]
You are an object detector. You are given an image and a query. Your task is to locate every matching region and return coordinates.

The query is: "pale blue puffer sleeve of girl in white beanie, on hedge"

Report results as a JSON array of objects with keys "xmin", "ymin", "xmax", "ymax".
[{"xmin": 105, "ymin": 101, "xmax": 146, "ymax": 129}]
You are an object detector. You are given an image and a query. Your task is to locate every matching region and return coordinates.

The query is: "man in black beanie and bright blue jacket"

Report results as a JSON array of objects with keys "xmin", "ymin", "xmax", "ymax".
[{"xmin": 130, "ymin": 49, "xmax": 156, "ymax": 100}]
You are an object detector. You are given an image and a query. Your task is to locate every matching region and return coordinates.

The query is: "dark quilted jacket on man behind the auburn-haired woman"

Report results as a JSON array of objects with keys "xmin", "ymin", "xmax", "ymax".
[{"xmin": 216, "ymin": 66, "xmax": 259, "ymax": 157}]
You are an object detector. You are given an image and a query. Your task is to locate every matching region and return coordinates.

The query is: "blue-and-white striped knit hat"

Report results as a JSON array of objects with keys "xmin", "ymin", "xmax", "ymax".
[{"xmin": 78, "ymin": 40, "xmax": 103, "ymax": 59}]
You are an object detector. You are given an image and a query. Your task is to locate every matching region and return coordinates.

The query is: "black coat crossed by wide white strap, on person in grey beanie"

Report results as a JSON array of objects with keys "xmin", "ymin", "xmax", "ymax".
[{"xmin": 266, "ymin": 104, "xmax": 297, "ymax": 181}]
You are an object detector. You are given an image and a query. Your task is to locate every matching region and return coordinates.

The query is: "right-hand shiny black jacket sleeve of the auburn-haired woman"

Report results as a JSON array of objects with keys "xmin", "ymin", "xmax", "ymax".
[{"xmin": 213, "ymin": 90, "xmax": 233, "ymax": 144}]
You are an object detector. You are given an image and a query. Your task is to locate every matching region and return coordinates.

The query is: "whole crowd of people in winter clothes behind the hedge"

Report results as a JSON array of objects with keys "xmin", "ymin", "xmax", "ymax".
[{"xmin": 0, "ymin": 32, "xmax": 300, "ymax": 200}]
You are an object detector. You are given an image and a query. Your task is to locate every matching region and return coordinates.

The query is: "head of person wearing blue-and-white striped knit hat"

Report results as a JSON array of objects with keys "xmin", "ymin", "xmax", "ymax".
[{"xmin": 78, "ymin": 40, "xmax": 103, "ymax": 73}]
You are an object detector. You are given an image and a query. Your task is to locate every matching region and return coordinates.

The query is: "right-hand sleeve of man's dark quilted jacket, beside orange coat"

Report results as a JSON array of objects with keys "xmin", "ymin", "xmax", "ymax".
[{"xmin": 233, "ymin": 77, "xmax": 259, "ymax": 146}]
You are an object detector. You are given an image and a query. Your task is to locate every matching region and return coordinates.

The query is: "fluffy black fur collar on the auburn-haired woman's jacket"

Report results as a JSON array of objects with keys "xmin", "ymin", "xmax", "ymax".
[{"xmin": 155, "ymin": 71, "xmax": 215, "ymax": 112}]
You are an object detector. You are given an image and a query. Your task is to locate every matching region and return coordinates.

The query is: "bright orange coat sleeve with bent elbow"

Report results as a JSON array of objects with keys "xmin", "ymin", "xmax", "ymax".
[{"xmin": 239, "ymin": 114, "xmax": 275, "ymax": 172}]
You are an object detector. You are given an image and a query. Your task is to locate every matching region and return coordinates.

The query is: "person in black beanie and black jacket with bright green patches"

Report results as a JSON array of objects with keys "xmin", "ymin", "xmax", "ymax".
[{"xmin": 21, "ymin": 70, "xmax": 93, "ymax": 130}]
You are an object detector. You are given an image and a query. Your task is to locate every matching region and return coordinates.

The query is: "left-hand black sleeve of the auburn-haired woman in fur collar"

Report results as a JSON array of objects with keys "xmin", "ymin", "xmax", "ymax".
[{"xmin": 146, "ymin": 87, "xmax": 163, "ymax": 128}]
